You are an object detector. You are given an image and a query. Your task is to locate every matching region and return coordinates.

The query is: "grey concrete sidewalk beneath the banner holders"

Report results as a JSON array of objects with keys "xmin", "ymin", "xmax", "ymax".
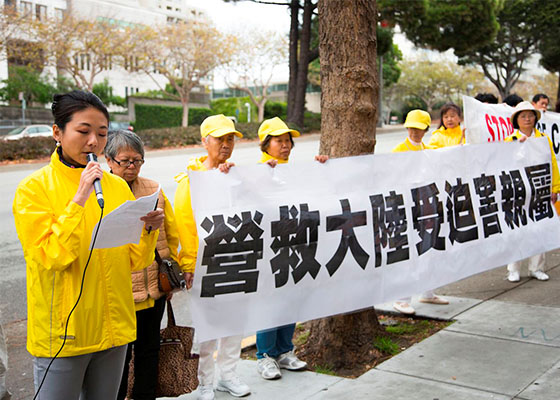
[{"xmin": 168, "ymin": 250, "xmax": 560, "ymax": 400}]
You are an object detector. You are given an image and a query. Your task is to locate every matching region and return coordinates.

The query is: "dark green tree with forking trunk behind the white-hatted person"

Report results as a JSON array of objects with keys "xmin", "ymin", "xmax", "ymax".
[{"xmin": 459, "ymin": 0, "xmax": 560, "ymax": 98}]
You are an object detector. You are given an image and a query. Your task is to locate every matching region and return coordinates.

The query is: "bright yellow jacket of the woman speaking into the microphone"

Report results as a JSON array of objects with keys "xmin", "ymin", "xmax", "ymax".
[{"xmin": 13, "ymin": 151, "xmax": 158, "ymax": 357}]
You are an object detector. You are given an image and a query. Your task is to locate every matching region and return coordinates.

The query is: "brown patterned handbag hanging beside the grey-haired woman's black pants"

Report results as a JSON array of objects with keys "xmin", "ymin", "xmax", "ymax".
[{"xmin": 127, "ymin": 300, "xmax": 198, "ymax": 398}]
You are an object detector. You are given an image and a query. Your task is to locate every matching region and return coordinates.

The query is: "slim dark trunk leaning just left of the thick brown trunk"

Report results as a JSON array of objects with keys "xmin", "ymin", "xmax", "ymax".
[{"xmin": 290, "ymin": 0, "xmax": 313, "ymax": 128}]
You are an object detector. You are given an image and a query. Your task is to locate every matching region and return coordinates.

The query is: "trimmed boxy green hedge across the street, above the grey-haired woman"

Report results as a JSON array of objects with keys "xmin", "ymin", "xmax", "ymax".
[{"xmin": 134, "ymin": 104, "xmax": 212, "ymax": 131}]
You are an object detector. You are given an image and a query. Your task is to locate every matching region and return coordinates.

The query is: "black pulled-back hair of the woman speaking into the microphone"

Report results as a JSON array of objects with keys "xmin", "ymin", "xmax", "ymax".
[{"xmin": 51, "ymin": 90, "xmax": 109, "ymax": 131}]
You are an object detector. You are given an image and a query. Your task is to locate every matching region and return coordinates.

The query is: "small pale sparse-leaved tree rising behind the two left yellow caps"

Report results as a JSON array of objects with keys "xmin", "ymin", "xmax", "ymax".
[{"xmin": 226, "ymin": 31, "xmax": 287, "ymax": 122}]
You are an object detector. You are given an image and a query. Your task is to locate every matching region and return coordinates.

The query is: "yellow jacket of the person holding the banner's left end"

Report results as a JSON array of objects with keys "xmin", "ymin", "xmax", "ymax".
[{"xmin": 173, "ymin": 156, "xmax": 208, "ymax": 273}]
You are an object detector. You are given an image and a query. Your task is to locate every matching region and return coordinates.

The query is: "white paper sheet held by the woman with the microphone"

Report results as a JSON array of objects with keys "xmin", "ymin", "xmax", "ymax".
[{"xmin": 90, "ymin": 186, "xmax": 161, "ymax": 249}]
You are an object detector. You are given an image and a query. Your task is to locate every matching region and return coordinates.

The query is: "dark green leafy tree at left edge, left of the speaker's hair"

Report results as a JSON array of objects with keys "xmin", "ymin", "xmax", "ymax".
[{"xmin": 0, "ymin": 66, "xmax": 57, "ymax": 104}]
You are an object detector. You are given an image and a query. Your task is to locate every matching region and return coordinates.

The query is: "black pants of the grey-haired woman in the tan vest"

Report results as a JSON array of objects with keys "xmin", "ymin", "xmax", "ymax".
[{"xmin": 117, "ymin": 296, "xmax": 165, "ymax": 400}]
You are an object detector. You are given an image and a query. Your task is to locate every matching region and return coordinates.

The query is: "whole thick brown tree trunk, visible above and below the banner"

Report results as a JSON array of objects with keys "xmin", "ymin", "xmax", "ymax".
[{"xmin": 305, "ymin": 0, "xmax": 383, "ymax": 369}]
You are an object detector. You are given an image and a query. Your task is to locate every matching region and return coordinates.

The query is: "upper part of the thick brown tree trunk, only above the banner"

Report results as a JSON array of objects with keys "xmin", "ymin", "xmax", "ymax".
[{"xmin": 319, "ymin": 0, "xmax": 379, "ymax": 157}]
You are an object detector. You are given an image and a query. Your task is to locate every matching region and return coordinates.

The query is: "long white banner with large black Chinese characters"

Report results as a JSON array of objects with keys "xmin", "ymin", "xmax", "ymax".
[{"xmin": 189, "ymin": 138, "xmax": 560, "ymax": 341}]
